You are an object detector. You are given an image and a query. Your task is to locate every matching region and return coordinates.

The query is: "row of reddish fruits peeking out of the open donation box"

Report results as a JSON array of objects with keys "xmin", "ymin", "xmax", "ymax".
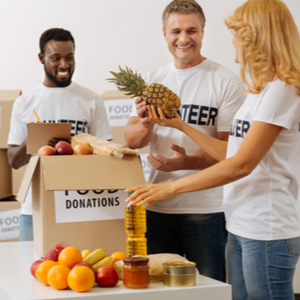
[{"xmin": 37, "ymin": 141, "xmax": 94, "ymax": 156}]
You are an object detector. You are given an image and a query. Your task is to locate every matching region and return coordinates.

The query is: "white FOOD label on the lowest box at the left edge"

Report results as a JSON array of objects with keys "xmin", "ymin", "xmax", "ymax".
[{"xmin": 0, "ymin": 209, "xmax": 21, "ymax": 241}]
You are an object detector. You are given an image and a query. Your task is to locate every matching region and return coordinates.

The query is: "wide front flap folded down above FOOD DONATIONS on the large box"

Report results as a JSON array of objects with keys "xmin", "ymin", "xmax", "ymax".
[{"xmin": 41, "ymin": 155, "xmax": 146, "ymax": 190}]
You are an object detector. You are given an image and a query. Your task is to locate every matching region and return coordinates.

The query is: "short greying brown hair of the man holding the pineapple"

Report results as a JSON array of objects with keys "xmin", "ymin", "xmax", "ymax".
[{"xmin": 162, "ymin": 0, "xmax": 206, "ymax": 28}]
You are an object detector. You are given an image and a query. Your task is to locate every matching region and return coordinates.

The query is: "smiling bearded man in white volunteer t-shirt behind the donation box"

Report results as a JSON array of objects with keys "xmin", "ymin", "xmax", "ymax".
[{"xmin": 7, "ymin": 28, "xmax": 112, "ymax": 241}]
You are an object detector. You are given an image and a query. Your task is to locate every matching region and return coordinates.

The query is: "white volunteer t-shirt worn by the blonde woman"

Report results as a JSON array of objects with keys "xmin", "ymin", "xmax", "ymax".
[{"xmin": 224, "ymin": 80, "xmax": 300, "ymax": 240}]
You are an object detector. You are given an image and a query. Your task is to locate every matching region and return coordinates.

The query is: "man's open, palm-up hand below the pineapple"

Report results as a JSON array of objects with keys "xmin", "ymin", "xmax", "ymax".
[{"xmin": 147, "ymin": 144, "xmax": 187, "ymax": 172}]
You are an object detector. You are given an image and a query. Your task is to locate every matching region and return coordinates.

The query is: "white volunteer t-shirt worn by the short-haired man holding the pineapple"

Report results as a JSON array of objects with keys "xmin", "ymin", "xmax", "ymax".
[{"xmin": 131, "ymin": 59, "xmax": 245, "ymax": 214}]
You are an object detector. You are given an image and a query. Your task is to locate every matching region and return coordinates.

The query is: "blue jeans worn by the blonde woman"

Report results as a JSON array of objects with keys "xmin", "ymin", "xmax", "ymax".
[{"xmin": 227, "ymin": 233, "xmax": 300, "ymax": 300}]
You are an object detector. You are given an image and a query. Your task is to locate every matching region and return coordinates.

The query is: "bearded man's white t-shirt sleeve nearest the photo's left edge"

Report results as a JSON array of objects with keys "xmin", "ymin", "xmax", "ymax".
[{"xmin": 7, "ymin": 96, "xmax": 27, "ymax": 145}]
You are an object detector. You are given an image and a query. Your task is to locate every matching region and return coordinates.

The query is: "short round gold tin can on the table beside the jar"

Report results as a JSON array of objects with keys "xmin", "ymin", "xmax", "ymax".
[{"xmin": 163, "ymin": 261, "xmax": 196, "ymax": 287}]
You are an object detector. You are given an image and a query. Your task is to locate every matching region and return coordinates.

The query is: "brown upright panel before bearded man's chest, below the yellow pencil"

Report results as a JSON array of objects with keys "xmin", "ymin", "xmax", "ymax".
[{"xmin": 27, "ymin": 123, "xmax": 72, "ymax": 154}]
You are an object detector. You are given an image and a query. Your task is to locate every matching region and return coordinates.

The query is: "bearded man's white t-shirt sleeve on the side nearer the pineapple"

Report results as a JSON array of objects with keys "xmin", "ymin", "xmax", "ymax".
[{"xmin": 89, "ymin": 95, "xmax": 113, "ymax": 140}]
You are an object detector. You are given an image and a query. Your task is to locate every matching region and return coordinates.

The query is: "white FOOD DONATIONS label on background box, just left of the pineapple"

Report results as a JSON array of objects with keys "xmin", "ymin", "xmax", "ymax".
[{"xmin": 104, "ymin": 99, "xmax": 133, "ymax": 127}]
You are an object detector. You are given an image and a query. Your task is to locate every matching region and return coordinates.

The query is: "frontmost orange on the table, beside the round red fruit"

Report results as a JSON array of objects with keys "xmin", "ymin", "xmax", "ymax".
[{"xmin": 68, "ymin": 266, "xmax": 95, "ymax": 292}]
